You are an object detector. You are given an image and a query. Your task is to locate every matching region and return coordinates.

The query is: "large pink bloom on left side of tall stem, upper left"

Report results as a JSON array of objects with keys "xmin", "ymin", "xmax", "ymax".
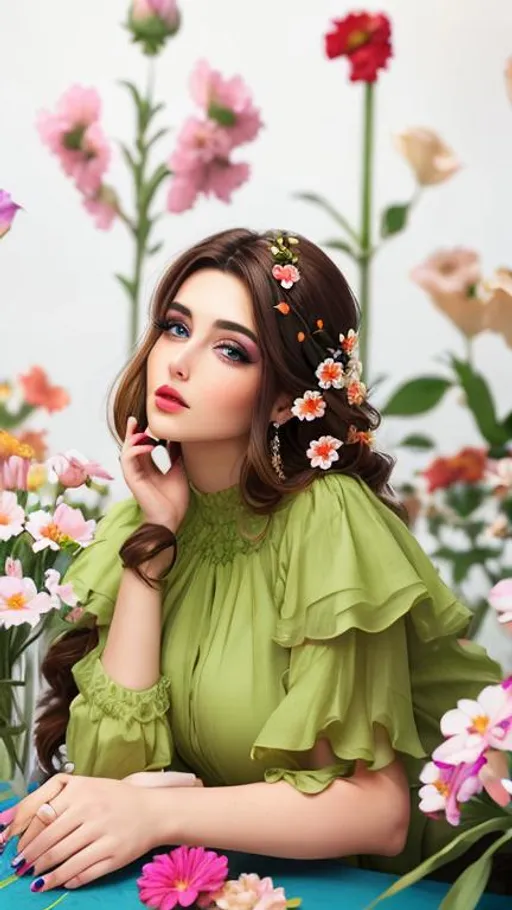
[{"xmin": 37, "ymin": 85, "xmax": 110, "ymax": 194}]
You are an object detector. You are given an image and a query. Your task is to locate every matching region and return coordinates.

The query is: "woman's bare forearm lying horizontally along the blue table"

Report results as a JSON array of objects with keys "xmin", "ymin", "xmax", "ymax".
[{"xmin": 155, "ymin": 764, "xmax": 410, "ymax": 859}]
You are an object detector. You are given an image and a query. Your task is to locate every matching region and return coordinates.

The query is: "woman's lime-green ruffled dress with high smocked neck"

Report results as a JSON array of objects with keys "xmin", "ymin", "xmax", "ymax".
[{"xmin": 62, "ymin": 474, "xmax": 501, "ymax": 872}]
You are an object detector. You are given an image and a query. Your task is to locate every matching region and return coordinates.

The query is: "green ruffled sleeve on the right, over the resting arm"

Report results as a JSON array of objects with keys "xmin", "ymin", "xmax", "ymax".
[{"xmin": 251, "ymin": 475, "xmax": 499, "ymax": 793}]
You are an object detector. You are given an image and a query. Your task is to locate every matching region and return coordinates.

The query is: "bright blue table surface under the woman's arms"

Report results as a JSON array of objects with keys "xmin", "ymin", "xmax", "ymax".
[{"xmin": 0, "ymin": 784, "xmax": 512, "ymax": 910}]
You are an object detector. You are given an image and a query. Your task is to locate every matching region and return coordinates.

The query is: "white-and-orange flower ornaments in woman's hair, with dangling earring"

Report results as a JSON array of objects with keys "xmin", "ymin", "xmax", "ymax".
[{"xmin": 270, "ymin": 235, "xmax": 373, "ymax": 480}]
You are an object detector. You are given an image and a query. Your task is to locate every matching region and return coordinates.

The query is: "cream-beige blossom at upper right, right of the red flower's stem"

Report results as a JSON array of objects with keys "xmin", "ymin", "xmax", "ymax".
[{"xmin": 393, "ymin": 127, "xmax": 462, "ymax": 186}]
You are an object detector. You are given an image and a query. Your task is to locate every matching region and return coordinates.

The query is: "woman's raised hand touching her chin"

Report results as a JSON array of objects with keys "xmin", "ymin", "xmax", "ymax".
[{"xmin": 120, "ymin": 417, "xmax": 190, "ymax": 533}]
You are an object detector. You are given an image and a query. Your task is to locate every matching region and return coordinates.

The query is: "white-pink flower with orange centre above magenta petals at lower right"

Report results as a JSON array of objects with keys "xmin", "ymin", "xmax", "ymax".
[{"xmin": 432, "ymin": 685, "xmax": 512, "ymax": 765}]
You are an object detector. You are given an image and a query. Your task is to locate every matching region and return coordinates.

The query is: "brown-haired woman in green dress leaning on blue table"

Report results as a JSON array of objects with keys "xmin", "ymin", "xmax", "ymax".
[{"xmin": 4, "ymin": 230, "xmax": 506, "ymax": 890}]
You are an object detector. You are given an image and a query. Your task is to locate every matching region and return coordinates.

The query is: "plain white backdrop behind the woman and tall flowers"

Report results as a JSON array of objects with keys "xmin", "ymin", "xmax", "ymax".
[{"xmin": 0, "ymin": 0, "xmax": 512, "ymax": 664}]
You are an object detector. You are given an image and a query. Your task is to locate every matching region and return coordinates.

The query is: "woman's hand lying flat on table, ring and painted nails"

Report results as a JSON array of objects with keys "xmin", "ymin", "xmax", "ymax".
[{"xmin": 4, "ymin": 774, "xmax": 174, "ymax": 891}]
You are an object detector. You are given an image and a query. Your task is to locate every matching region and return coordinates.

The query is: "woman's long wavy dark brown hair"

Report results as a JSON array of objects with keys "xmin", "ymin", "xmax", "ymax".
[{"xmin": 35, "ymin": 229, "xmax": 401, "ymax": 773}]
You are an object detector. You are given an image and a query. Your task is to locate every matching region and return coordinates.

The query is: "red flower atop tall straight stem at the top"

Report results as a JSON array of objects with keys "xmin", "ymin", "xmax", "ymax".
[{"xmin": 325, "ymin": 13, "xmax": 393, "ymax": 82}]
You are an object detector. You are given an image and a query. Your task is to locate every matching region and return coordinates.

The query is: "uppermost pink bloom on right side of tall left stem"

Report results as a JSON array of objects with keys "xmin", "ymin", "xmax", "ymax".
[{"xmin": 190, "ymin": 60, "xmax": 262, "ymax": 149}]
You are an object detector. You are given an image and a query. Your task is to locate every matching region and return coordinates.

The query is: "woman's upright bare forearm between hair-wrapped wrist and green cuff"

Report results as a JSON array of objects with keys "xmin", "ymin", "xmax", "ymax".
[{"xmin": 101, "ymin": 552, "xmax": 169, "ymax": 690}]
